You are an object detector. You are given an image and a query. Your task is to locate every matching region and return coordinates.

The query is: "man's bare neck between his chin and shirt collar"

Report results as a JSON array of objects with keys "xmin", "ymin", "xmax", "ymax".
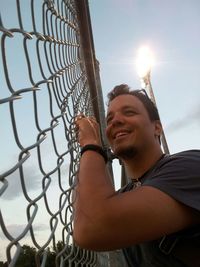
[{"xmin": 123, "ymin": 149, "xmax": 163, "ymax": 180}]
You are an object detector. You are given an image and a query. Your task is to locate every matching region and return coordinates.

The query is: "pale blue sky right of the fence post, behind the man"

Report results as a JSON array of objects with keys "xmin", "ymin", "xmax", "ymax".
[{"xmin": 89, "ymin": 0, "xmax": 200, "ymax": 153}]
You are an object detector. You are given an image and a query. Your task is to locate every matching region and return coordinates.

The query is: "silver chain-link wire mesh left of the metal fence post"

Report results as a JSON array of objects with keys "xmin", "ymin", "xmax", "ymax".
[{"xmin": 0, "ymin": 0, "xmax": 106, "ymax": 267}]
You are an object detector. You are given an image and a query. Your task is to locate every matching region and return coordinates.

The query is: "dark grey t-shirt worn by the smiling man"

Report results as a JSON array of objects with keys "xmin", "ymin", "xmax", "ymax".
[{"xmin": 120, "ymin": 150, "xmax": 200, "ymax": 267}]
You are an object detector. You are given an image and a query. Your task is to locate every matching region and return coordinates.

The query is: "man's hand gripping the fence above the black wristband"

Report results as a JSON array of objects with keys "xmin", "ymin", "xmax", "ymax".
[{"xmin": 75, "ymin": 114, "xmax": 101, "ymax": 147}]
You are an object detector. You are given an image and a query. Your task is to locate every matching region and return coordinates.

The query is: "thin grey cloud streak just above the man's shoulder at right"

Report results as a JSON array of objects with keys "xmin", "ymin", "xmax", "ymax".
[{"xmin": 165, "ymin": 104, "xmax": 200, "ymax": 133}]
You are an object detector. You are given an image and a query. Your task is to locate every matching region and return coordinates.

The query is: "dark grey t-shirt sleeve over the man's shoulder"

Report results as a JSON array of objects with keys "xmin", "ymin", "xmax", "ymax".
[{"xmin": 143, "ymin": 150, "xmax": 200, "ymax": 214}]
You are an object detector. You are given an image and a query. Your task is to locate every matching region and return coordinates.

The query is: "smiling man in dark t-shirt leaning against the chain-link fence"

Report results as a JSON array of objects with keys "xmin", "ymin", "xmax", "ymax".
[{"xmin": 74, "ymin": 85, "xmax": 200, "ymax": 267}]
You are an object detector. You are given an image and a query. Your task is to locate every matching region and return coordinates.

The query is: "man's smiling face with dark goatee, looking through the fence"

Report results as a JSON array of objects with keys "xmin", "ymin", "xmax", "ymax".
[{"xmin": 106, "ymin": 94, "xmax": 161, "ymax": 159}]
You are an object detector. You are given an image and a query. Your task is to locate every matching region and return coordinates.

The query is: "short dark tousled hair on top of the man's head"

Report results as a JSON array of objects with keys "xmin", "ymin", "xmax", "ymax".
[{"xmin": 108, "ymin": 84, "xmax": 160, "ymax": 121}]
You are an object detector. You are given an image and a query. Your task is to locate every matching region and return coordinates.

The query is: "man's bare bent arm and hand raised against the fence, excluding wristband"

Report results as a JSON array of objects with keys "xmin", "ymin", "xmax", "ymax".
[{"xmin": 74, "ymin": 116, "xmax": 199, "ymax": 251}]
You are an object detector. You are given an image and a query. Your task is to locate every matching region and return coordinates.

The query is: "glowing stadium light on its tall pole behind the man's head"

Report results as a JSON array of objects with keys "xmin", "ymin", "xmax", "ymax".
[{"xmin": 137, "ymin": 47, "xmax": 169, "ymax": 154}]
